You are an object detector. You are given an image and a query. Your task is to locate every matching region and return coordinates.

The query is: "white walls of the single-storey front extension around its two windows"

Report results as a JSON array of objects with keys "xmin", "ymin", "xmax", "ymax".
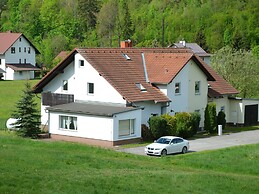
[{"xmin": 49, "ymin": 110, "xmax": 141, "ymax": 141}]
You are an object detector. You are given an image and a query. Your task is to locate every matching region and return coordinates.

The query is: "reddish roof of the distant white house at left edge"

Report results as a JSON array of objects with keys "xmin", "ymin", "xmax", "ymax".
[{"xmin": 0, "ymin": 32, "xmax": 40, "ymax": 54}]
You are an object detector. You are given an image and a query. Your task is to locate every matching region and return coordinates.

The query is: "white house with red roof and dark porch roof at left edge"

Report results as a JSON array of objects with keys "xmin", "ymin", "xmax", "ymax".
[{"xmin": 0, "ymin": 32, "xmax": 40, "ymax": 80}]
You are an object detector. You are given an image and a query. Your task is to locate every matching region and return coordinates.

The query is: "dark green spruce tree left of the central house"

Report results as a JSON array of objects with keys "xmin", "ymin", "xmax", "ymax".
[{"xmin": 12, "ymin": 83, "xmax": 41, "ymax": 138}]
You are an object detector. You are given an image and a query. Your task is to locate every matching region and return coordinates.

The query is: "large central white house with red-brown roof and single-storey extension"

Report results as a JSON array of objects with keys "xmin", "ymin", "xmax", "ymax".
[{"xmin": 34, "ymin": 43, "xmax": 241, "ymax": 146}]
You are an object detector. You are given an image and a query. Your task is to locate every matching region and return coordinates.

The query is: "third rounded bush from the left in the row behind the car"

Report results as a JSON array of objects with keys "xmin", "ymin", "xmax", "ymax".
[{"xmin": 175, "ymin": 112, "xmax": 192, "ymax": 138}]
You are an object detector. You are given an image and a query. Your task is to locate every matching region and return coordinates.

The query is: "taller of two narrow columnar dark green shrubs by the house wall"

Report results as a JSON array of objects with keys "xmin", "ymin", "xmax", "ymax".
[{"xmin": 204, "ymin": 103, "xmax": 217, "ymax": 133}]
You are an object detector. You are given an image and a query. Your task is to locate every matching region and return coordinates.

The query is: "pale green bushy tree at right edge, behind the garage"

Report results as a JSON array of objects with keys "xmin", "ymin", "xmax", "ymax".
[{"xmin": 211, "ymin": 46, "xmax": 259, "ymax": 98}]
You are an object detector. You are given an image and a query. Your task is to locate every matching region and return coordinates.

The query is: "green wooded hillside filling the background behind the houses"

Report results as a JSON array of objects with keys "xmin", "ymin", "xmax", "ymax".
[{"xmin": 0, "ymin": 0, "xmax": 259, "ymax": 97}]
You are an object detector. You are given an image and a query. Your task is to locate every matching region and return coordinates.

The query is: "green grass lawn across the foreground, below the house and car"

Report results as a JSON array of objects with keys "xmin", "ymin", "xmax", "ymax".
[{"xmin": 0, "ymin": 131, "xmax": 259, "ymax": 194}]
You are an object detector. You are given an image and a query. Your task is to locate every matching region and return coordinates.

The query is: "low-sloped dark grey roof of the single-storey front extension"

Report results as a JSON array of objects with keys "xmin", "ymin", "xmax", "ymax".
[{"xmin": 47, "ymin": 101, "xmax": 141, "ymax": 117}]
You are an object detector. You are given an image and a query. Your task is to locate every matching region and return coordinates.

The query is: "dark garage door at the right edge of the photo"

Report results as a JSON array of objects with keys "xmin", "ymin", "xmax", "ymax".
[{"xmin": 245, "ymin": 104, "xmax": 258, "ymax": 126}]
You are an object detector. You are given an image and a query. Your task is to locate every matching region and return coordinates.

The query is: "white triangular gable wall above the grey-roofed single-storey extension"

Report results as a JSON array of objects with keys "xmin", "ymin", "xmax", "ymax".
[{"xmin": 43, "ymin": 54, "xmax": 126, "ymax": 104}]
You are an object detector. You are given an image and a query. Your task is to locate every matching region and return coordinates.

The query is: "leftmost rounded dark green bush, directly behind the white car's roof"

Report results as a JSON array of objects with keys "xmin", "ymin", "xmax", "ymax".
[{"xmin": 148, "ymin": 116, "xmax": 168, "ymax": 139}]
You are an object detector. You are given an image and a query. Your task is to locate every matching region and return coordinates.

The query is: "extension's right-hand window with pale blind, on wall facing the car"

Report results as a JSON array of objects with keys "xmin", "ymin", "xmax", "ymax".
[{"xmin": 119, "ymin": 119, "xmax": 135, "ymax": 137}]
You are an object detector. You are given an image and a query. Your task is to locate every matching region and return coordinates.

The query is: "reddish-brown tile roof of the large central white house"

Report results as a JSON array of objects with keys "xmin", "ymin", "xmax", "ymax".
[{"xmin": 34, "ymin": 48, "xmax": 240, "ymax": 102}]
